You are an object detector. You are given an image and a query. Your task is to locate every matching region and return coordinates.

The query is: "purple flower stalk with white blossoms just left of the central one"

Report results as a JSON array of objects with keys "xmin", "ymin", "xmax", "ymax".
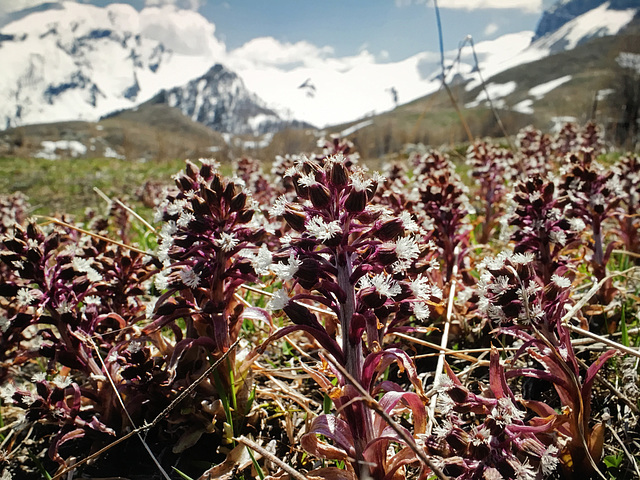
[{"xmin": 142, "ymin": 160, "xmax": 270, "ymax": 450}]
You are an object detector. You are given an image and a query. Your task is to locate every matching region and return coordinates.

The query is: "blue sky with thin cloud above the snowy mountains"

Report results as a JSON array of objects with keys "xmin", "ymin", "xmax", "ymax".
[{"xmin": 0, "ymin": 0, "xmax": 553, "ymax": 62}]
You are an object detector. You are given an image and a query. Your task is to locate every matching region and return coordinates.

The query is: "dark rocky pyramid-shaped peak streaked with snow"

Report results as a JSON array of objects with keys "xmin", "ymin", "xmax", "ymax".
[{"xmin": 150, "ymin": 64, "xmax": 306, "ymax": 135}]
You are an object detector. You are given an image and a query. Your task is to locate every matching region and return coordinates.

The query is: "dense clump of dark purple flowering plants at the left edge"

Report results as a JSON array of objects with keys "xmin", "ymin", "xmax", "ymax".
[{"xmin": 0, "ymin": 217, "xmax": 157, "ymax": 464}]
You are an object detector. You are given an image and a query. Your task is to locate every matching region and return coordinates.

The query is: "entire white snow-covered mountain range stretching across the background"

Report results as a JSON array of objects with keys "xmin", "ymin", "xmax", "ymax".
[{"xmin": 0, "ymin": 0, "xmax": 639, "ymax": 133}]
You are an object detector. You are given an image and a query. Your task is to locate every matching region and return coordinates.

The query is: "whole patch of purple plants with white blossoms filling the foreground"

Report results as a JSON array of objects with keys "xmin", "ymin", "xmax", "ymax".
[{"xmin": 0, "ymin": 125, "xmax": 640, "ymax": 480}]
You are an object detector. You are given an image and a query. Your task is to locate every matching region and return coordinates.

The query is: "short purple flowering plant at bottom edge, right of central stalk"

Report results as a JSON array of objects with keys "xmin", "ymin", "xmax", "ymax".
[{"xmin": 421, "ymin": 348, "xmax": 559, "ymax": 480}]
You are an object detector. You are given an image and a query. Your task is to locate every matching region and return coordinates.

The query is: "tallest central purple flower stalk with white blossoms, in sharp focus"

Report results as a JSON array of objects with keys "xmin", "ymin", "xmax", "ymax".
[{"xmin": 262, "ymin": 154, "xmax": 438, "ymax": 479}]
